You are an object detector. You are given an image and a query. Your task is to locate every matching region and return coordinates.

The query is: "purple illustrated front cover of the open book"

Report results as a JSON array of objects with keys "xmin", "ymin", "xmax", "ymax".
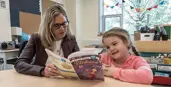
[{"xmin": 71, "ymin": 55, "xmax": 104, "ymax": 80}]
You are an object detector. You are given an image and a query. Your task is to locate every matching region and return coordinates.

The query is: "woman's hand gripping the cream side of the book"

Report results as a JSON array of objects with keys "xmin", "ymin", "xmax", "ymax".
[{"xmin": 41, "ymin": 64, "xmax": 60, "ymax": 78}]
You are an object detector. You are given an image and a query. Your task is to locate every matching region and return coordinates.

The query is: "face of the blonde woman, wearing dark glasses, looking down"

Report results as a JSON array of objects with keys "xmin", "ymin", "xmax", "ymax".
[{"xmin": 52, "ymin": 14, "xmax": 68, "ymax": 40}]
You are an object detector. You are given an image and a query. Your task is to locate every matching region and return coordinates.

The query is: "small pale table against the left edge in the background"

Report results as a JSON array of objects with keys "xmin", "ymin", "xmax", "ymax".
[{"xmin": 0, "ymin": 49, "xmax": 19, "ymax": 70}]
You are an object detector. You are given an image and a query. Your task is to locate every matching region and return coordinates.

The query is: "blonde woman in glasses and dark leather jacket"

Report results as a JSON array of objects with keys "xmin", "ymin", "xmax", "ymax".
[{"xmin": 14, "ymin": 5, "xmax": 79, "ymax": 77}]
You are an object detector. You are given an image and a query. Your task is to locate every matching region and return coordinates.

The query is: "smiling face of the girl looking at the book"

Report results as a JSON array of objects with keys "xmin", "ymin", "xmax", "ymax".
[{"xmin": 103, "ymin": 36, "xmax": 129, "ymax": 60}]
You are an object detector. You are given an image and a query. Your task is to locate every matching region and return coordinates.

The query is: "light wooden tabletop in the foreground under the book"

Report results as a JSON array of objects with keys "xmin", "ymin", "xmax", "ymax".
[{"xmin": 0, "ymin": 70, "xmax": 153, "ymax": 87}]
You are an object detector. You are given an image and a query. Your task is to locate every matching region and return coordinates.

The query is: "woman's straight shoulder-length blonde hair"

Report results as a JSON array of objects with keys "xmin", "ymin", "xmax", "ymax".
[{"xmin": 38, "ymin": 4, "xmax": 72, "ymax": 48}]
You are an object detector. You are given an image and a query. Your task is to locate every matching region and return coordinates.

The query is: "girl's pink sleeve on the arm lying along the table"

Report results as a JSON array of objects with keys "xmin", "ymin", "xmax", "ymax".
[{"xmin": 113, "ymin": 58, "xmax": 153, "ymax": 84}]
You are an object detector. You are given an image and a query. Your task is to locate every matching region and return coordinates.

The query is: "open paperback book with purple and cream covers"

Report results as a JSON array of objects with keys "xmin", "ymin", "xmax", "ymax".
[{"xmin": 45, "ymin": 49, "xmax": 104, "ymax": 80}]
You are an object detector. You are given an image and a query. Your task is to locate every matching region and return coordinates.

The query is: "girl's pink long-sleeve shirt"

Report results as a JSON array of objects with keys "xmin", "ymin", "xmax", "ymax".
[{"xmin": 101, "ymin": 53, "xmax": 153, "ymax": 84}]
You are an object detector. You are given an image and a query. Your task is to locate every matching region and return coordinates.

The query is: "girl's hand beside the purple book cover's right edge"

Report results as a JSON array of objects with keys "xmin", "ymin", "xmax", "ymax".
[{"xmin": 103, "ymin": 64, "xmax": 115, "ymax": 77}]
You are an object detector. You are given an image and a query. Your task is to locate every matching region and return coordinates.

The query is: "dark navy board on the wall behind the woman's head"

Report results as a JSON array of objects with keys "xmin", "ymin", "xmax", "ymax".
[{"xmin": 10, "ymin": 0, "xmax": 40, "ymax": 27}]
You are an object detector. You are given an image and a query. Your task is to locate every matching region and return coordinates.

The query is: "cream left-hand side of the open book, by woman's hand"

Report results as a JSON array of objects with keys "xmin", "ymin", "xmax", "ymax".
[{"xmin": 45, "ymin": 49, "xmax": 79, "ymax": 79}]
